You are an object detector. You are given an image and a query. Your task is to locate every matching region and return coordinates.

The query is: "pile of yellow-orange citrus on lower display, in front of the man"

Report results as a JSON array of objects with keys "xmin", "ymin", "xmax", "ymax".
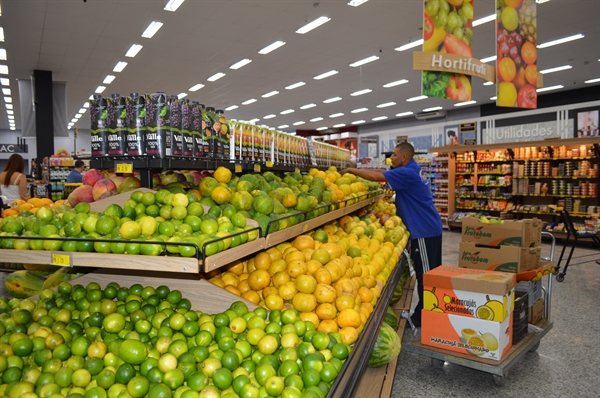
[{"xmin": 210, "ymin": 205, "xmax": 408, "ymax": 344}]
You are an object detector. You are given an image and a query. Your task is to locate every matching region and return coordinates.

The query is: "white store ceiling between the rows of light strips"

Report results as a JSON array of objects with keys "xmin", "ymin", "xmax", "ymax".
[{"xmin": 0, "ymin": 0, "xmax": 600, "ymax": 131}]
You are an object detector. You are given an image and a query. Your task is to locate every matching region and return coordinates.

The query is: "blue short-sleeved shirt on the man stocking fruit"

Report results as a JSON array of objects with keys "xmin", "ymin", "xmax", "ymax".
[{"xmin": 383, "ymin": 159, "xmax": 442, "ymax": 239}]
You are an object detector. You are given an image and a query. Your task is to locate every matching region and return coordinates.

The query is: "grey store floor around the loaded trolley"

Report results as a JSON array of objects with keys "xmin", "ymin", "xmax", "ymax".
[{"xmin": 392, "ymin": 231, "xmax": 600, "ymax": 398}]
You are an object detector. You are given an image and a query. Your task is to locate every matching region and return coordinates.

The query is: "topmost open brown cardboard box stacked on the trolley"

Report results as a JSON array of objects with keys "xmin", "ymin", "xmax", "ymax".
[{"xmin": 462, "ymin": 217, "xmax": 542, "ymax": 247}]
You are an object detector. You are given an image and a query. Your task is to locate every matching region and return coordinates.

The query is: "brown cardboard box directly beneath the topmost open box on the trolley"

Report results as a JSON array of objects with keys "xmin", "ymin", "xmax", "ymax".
[{"xmin": 458, "ymin": 242, "xmax": 542, "ymax": 273}]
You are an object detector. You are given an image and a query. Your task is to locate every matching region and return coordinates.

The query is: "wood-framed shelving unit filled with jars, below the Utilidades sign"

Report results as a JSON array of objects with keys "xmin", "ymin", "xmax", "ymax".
[{"xmin": 430, "ymin": 137, "xmax": 600, "ymax": 232}]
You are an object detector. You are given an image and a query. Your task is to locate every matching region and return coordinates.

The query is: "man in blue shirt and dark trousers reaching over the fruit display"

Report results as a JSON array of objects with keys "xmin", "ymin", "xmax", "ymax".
[{"xmin": 341, "ymin": 142, "xmax": 442, "ymax": 327}]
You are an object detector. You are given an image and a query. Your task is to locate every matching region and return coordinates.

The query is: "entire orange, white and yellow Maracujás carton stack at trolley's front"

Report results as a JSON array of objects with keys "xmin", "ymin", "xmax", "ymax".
[{"xmin": 421, "ymin": 266, "xmax": 516, "ymax": 361}]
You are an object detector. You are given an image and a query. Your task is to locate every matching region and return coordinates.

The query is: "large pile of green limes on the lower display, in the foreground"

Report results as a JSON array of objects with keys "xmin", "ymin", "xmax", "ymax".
[{"xmin": 0, "ymin": 282, "xmax": 350, "ymax": 398}]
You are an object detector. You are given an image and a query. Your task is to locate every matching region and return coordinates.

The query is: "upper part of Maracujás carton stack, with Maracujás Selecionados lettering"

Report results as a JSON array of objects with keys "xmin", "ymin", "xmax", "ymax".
[{"xmin": 423, "ymin": 266, "xmax": 516, "ymax": 322}]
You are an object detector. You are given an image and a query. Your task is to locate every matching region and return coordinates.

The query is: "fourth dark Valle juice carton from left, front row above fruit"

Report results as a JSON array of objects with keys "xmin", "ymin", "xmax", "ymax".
[{"xmin": 146, "ymin": 92, "xmax": 169, "ymax": 159}]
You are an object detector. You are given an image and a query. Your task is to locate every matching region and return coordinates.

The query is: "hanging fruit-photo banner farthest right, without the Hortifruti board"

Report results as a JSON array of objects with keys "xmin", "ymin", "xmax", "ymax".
[{"xmin": 496, "ymin": 0, "xmax": 541, "ymax": 109}]
